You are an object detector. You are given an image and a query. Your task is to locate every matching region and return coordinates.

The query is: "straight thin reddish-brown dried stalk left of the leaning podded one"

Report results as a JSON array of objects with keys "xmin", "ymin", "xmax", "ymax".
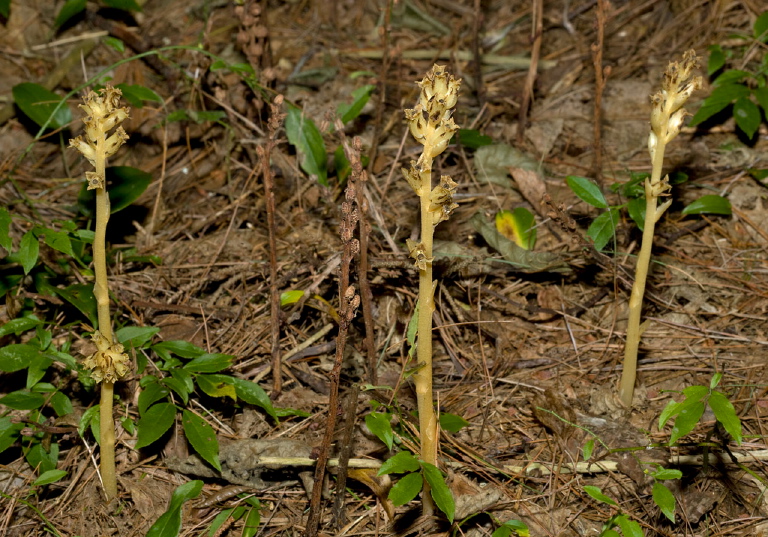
[{"xmin": 256, "ymin": 95, "xmax": 285, "ymax": 397}]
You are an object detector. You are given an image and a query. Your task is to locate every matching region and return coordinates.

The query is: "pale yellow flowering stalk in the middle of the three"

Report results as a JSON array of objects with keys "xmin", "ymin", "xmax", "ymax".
[{"xmin": 403, "ymin": 65, "xmax": 461, "ymax": 515}]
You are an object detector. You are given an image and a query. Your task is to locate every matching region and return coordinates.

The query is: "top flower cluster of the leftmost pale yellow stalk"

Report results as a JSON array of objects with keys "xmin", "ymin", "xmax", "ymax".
[{"xmin": 69, "ymin": 86, "xmax": 128, "ymax": 190}]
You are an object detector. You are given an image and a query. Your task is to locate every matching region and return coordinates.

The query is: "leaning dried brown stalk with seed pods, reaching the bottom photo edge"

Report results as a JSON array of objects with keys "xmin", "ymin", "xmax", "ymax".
[{"xmin": 304, "ymin": 122, "xmax": 360, "ymax": 537}]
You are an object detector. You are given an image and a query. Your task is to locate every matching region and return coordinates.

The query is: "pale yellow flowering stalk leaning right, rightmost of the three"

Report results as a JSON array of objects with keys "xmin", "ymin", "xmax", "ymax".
[{"xmin": 619, "ymin": 50, "xmax": 701, "ymax": 408}]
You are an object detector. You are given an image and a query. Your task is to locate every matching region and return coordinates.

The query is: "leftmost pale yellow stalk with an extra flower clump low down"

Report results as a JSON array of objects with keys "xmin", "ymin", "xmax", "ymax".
[{"xmin": 69, "ymin": 86, "xmax": 130, "ymax": 502}]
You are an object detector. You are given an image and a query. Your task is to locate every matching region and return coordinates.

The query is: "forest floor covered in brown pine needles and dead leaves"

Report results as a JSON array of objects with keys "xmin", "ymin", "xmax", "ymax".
[{"xmin": 0, "ymin": 0, "xmax": 768, "ymax": 537}]
